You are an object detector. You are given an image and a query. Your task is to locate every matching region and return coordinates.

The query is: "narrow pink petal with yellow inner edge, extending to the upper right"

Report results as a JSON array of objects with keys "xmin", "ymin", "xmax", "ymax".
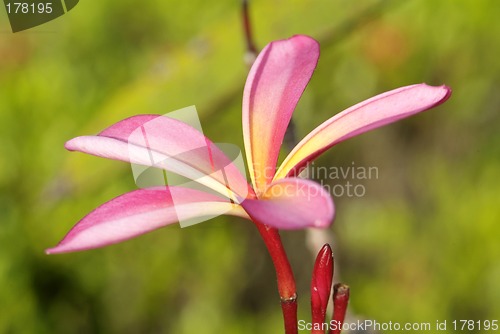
[{"xmin": 274, "ymin": 84, "xmax": 451, "ymax": 180}]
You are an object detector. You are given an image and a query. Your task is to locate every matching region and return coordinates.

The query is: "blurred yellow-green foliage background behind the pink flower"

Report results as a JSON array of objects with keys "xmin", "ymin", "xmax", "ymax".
[{"xmin": 0, "ymin": 0, "xmax": 500, "ymax": 334}]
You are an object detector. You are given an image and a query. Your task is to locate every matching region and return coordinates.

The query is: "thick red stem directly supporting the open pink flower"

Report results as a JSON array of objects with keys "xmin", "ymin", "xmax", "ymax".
[{"xmin": 255, "ymin": 222, "xmax": 298, "ymax": 334}]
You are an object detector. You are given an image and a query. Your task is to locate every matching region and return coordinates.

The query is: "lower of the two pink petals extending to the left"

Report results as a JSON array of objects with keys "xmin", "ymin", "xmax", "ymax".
[{"xmin": 46, "ymin": 187, "xmax": 248, "ymax": 254}]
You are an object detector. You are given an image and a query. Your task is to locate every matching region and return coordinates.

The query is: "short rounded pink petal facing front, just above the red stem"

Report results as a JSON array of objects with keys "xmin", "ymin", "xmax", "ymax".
[{"xmin": 241, "ymin": 178, "xmax": 335, "ymax": 230}]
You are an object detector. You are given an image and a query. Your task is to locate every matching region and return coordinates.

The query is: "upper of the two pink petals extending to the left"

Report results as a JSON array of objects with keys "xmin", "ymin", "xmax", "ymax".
[{"xmin": 65, "ymin": 115, "xmax": 253, "ymax": 201}]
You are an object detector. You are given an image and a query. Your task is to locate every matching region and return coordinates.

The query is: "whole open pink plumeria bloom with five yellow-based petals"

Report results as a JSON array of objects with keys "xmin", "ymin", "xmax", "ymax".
[{"xmin": 47, "ymin": 35, "xmax": 451, "ymax": 253}]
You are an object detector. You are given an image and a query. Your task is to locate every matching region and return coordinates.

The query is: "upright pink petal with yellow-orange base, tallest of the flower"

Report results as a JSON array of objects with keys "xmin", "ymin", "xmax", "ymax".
[{"xmin": 243, "ymin": 35, "xmax": 319, "ymax": 193}]
